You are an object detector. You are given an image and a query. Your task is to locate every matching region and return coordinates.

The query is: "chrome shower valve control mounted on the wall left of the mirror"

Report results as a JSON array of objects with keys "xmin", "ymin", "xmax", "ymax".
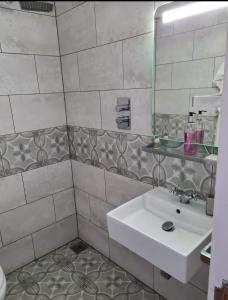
[{"xmin": 116, "ymin": 97, "xmax": 131, "ymax": 130}]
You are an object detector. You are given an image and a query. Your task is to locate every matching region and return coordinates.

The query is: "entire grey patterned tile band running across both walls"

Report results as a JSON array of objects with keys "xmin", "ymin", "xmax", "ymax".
[{"xmin": 0, "ymin": 126, "xmax": 216, "ymax": 194}]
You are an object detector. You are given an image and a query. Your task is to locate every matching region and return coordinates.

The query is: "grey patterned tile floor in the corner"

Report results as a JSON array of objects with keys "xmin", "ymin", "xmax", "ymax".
[{"xmin": 6, "ymin": 243, "xmax": 165, "ymax": 300}]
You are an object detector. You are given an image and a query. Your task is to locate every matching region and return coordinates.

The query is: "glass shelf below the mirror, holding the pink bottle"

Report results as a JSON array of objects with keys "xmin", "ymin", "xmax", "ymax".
[{"xmin": 142, "ymin": 136, "xmax": 218, "ymax": 164}]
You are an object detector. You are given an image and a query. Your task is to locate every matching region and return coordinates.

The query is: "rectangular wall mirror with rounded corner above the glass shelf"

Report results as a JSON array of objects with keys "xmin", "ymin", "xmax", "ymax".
[{"xmin": 154, "ymin": 2, "xmax": 228, "ymax": 146}]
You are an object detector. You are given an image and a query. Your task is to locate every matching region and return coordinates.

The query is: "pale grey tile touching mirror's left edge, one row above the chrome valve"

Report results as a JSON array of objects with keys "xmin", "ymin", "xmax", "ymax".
[{"xmin": 123, "ymin": 33, "xmax": 153, "ymax": 88}]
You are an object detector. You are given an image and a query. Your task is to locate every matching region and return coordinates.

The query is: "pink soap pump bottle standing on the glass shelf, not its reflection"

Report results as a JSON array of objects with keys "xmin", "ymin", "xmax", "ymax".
[{"xmin": 184, "ymin": 112, "xmax": 197, "ymax": 155}]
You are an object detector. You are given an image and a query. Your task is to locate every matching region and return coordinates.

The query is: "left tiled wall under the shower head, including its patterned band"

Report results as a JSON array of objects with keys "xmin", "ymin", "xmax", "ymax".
[{"xmin": 0, "ymin": 1, "xmax": 77, "ymax": 273}]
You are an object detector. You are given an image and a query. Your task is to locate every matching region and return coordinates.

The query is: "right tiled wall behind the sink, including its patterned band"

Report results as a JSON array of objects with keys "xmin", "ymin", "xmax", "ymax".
[{"xmin": 56, "ymin": 1, "xmax": 211, "ymax": 300}]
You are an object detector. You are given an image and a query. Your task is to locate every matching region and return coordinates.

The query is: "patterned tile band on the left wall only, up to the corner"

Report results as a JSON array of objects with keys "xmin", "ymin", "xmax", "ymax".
[{"xmin": 0, "ymin": 126, "xmax": 69, "ymax": 177}]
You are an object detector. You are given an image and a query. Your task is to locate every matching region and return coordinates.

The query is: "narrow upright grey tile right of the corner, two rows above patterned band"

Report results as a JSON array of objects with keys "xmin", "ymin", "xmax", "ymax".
[{"xmin": 61, "ymin": 53, "xmax": 79, "ymax": 92}]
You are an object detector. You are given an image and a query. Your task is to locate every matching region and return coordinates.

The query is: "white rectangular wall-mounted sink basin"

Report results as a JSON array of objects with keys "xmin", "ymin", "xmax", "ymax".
[{"xmin": 107, "ymin": 187, "xmax": 212, "ymax": 283}]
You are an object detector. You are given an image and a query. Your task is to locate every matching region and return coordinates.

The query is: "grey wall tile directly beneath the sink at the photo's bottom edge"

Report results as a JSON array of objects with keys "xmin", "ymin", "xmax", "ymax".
[{"xmin": 154, "ymin": 268, "xmax": 207, "ymax": 300}]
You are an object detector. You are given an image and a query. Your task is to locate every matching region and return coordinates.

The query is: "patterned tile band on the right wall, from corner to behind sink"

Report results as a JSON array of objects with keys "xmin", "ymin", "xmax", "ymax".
[{"xmin": 68, "ymin": 126, "xmax": 215, "ymax": 194}]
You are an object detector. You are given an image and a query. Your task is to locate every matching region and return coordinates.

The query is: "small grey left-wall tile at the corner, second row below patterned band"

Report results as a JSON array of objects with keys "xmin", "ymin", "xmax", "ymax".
[{"xmin": 53, "ymin": 188, "xmax": 75, "ymax": 221}]
